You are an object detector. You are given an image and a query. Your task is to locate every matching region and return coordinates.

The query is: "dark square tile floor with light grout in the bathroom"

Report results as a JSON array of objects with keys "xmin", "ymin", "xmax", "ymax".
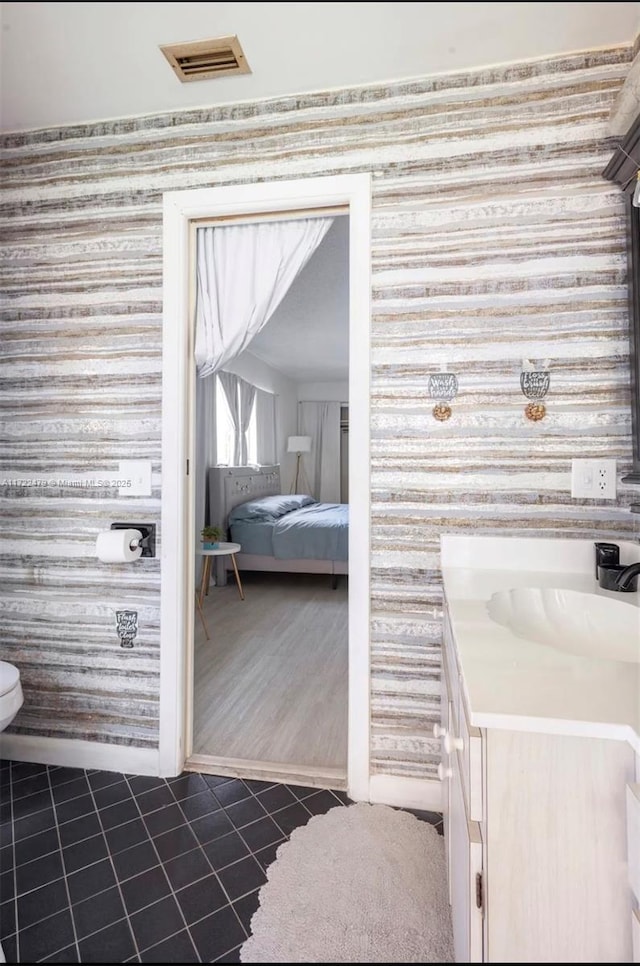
[{"xmin": 0, "ymin": 761, "xmax": 441, "ymax": 963}]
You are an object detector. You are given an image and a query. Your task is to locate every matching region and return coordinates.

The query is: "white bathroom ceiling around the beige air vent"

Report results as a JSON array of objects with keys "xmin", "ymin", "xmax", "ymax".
[{"xmin": 0, "ymin": 2, "xmax": 639, "ymax": 131}]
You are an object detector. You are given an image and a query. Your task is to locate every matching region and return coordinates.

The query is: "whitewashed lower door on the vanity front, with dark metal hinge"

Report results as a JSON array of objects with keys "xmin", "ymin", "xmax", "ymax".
[{"xmin": 447, "ymin": 755, "xmax": 483, "ymax": 963}]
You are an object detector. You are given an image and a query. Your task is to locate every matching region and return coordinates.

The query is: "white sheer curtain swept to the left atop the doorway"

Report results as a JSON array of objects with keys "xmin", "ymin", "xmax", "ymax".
[{"xmin": 195, "ymin": 218, "xmax": 333, "ymax": 378}]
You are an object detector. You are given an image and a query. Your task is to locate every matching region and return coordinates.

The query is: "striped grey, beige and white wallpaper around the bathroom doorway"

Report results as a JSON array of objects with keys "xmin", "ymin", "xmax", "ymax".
[{"xmin": 0, "ymin": 47, "xmax": 637, "ymax": 777}]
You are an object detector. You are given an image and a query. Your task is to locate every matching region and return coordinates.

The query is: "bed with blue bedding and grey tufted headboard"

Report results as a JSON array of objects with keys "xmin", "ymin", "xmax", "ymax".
[{"xmin": 209, "ymin": 466, "xmax": 349, "ymax": 583}]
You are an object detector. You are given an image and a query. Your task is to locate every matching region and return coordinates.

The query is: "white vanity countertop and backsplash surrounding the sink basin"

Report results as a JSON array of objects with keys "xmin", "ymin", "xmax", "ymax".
[{"xmin": 442, "ymin": 536, "xmax": 640, "ymax": 754}]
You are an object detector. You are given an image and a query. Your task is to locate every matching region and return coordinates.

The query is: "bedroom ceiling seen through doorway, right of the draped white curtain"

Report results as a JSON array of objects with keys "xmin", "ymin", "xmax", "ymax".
[{"xmin": 248, "ymin": 216, "xmax": 349, "ymax": 382}]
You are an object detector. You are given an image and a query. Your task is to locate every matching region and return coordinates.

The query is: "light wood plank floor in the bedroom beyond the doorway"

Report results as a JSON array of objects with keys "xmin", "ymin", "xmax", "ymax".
[{"xmin": 193, "ymin": 573, "xmax": 348, "ymax": 775}]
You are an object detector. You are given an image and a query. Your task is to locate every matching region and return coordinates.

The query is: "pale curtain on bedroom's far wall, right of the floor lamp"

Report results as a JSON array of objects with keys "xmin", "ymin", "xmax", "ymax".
[{"xmin": 298, "ymin": 402, "xmax": 340, "ymax": 503}]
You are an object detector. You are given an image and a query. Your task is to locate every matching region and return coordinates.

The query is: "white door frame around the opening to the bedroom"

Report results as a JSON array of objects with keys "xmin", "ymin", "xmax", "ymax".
[{"xmin": 159, "ymin": 174, "xmax": 371, "ymax": 801}]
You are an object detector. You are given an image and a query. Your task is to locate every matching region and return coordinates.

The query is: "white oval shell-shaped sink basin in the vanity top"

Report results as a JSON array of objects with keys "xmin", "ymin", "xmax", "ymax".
[{"xmin": 487, "ymin": 587, "xmax": 640, "ymax": 664}]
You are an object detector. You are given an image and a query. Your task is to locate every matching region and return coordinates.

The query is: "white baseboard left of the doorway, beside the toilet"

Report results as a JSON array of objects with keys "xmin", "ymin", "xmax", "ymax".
[{"xmin": 0, "ymin": 731, "xmax": 159, "ymax": 775}]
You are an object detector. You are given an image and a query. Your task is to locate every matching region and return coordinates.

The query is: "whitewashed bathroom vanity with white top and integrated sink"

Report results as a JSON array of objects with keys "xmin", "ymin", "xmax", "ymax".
[{"xmin": 435, "ymin": 536, "xmax": 640, "ymax": 963}]
